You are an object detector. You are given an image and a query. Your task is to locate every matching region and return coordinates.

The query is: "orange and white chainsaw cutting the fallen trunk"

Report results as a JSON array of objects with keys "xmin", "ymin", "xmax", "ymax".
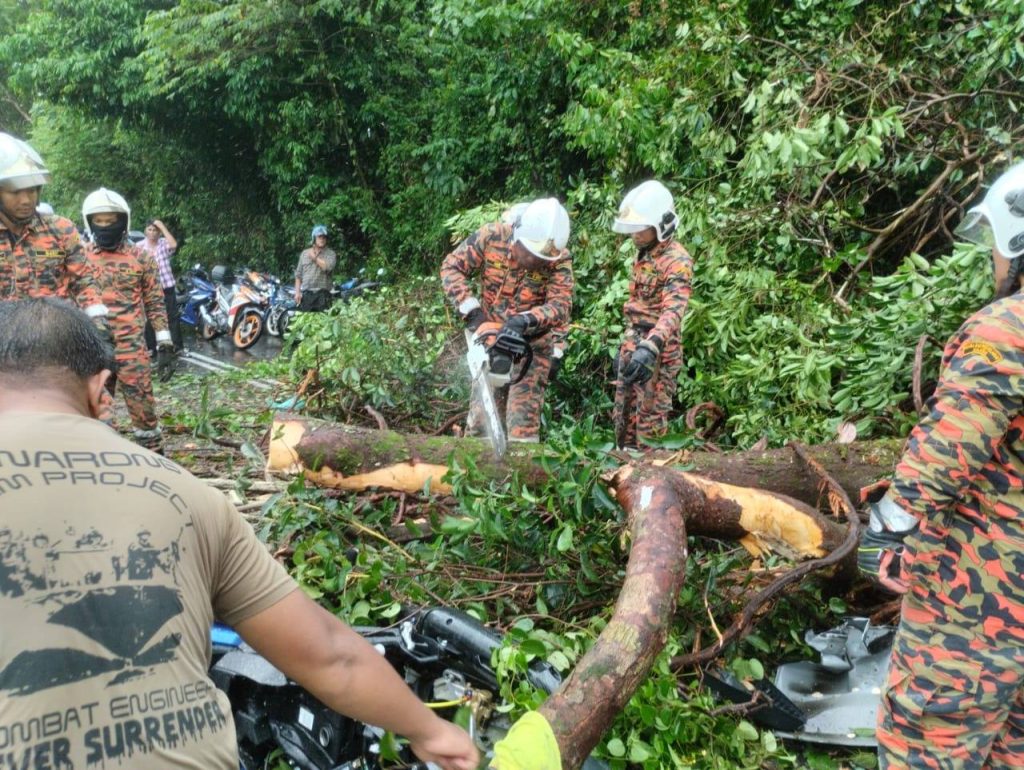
[{"xmin": 466, "ymin": 322, "xmax": 534, "ymax": 460}]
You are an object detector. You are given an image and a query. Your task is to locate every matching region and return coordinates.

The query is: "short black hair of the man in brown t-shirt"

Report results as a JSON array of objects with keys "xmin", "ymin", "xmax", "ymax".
[{"xmin": 0, "ymin": 297, "xmax": 115, "ymax": 387}]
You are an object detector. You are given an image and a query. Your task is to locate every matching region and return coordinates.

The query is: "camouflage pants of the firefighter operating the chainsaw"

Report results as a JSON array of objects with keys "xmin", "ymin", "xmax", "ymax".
[{"xmin": 466, "ymin": 334, "xmax": 552, "ymax": 441}]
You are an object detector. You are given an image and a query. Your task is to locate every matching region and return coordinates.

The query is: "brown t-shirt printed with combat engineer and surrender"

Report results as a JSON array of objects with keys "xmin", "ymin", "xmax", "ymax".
[{"xmin": 0, "ymin": 413, "xmax": 296, "ymax": 770}]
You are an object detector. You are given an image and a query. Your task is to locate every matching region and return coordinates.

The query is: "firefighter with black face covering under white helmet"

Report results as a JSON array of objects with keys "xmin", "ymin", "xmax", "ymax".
[{"xmin": 82, "ymin": 187, "xmax": 174, "ymax": 452}]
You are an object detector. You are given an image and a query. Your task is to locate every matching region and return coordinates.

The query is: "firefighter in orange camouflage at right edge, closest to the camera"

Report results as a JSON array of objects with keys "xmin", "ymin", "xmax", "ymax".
[{"xmin": 858, "ymin": 159, "xmax": 1024, "ymax": 770}]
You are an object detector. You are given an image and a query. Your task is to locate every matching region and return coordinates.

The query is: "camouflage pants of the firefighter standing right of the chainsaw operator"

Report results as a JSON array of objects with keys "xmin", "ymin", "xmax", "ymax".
[{"xmin": 612, "ymin": 330, "xmax": 683, "ymax": 446}]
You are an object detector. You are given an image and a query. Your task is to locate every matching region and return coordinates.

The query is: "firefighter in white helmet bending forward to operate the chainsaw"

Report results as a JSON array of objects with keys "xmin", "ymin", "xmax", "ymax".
[{"xmin": 441, "ymin": 198, "xmax": 573, "ymax": 441}]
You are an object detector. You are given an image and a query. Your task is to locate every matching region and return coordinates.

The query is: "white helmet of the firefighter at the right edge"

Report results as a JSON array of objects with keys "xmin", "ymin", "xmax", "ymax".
[{"xmin": 956, "ymin": 163, "xmax": 1024, "ymax": 259}]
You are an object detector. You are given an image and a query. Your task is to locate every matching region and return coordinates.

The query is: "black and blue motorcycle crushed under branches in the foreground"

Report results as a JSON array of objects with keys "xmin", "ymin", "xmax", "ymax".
[{"xmin": 210, "ymin": 607, "xmax": 604, "ymax": 770}]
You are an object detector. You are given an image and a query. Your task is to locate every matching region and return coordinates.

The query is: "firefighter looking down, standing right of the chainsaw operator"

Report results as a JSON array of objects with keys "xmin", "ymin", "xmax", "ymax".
[{"xmin": 611, "ymin": 180, "xmax": 693, "ymax": 446}]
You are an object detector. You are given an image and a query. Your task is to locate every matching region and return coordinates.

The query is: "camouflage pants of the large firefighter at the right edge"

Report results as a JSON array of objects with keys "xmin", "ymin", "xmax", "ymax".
[{"xmin": 878, "ymin": 515, "xmax": 1024, "ymax": 770}]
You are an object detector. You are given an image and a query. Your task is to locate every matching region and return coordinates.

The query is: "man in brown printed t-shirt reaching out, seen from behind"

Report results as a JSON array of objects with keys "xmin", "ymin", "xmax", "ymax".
[{"xmin": 0, "ymin": 299, "xmax": 477, "ymax": 770}]
